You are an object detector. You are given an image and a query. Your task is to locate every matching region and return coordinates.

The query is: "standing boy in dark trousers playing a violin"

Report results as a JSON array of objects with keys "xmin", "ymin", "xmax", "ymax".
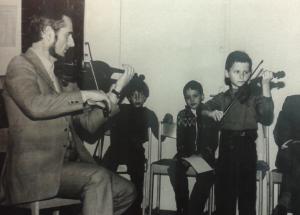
[{"xmin": 202, "ymin": 51, "xmax": 274, "ymax": 215}]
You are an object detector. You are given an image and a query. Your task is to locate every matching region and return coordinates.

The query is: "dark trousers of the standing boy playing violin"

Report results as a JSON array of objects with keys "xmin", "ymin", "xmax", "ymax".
[{"xmin": 216, "ymin": 130, "xmax": 257, "ymax": 215}]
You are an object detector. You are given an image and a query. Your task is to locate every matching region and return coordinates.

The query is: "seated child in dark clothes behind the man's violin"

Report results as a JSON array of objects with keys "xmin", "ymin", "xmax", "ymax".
[{"xmin": 103, "ymin": 77, "xmax": 172, "ymax": 215}]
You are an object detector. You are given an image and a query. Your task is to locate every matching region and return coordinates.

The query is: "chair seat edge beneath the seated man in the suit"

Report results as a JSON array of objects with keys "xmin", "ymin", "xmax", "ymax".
[{"xmin": 17, "ymin": 198, "xmax": 81, "ymax": 209}]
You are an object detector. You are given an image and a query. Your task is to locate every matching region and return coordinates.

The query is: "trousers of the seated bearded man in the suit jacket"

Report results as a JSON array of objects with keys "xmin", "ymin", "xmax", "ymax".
[{"xmin": 58, "ymin": 162, "xmax": 136, "ymax": 215}]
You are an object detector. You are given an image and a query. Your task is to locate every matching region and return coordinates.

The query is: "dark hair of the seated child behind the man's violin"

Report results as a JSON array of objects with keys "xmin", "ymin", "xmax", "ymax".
[{"xmin": 126, "ymin": 75, "xmax": 149, "ymax": 98}]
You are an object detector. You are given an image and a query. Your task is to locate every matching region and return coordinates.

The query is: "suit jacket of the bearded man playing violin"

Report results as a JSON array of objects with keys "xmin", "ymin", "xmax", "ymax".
[{"xmin": 2, "ymin": 49, "xmax": 117, "ymax": 204}]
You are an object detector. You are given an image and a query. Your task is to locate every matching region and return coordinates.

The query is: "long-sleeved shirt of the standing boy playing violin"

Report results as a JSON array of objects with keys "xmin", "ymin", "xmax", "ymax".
[{"xmin": 206, "ymin": 89, "xmax": 274, "ymax": 131}]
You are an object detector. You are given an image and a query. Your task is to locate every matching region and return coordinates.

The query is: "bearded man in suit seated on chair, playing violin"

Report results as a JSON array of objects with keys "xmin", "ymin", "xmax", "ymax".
[{"xmin": 0, "ymin": 8, "xmax": 135, "ymax": 215}]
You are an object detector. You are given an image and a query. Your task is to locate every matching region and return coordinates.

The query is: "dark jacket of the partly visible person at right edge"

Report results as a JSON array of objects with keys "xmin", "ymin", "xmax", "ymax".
[{"xmin": 273, "ymin": 95, "xmax": 300, "ymax": 172}]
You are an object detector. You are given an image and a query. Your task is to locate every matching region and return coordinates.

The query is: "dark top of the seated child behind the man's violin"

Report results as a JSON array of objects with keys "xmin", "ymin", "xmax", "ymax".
[{"xmin": 110, "ymin": 104, "xmax": 159, "ymax": 161}]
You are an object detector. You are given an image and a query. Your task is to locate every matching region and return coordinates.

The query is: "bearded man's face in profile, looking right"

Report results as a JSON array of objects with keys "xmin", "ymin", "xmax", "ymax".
[{"xmin": 49, "ymin": 16, "xmax": 75, "ymax": 58}]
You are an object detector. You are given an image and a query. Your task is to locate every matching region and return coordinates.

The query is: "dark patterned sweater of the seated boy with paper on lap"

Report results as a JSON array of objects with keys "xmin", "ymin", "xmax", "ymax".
[{"xmin": 176, "ymin": 104, "xmax": 218, "ymax": 166}]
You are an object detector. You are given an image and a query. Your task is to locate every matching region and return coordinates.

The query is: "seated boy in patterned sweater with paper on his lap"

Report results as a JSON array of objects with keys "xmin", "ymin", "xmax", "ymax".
[{"xmin": 169, "ymin": 80, "xmax": 218, "ymax": 215}]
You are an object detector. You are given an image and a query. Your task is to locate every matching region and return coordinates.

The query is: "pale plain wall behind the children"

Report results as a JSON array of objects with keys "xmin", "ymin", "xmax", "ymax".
[{"xmin": 85, "ymin": 0, "xmax": 300, "ymax": 212}]
